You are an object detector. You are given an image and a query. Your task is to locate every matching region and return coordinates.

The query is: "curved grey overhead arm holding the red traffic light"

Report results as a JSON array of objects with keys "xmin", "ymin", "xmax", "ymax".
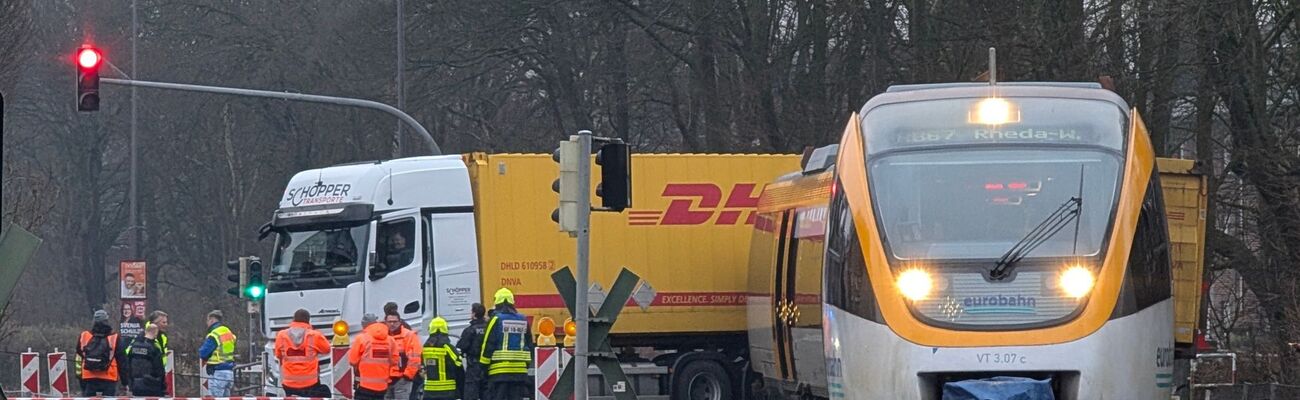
[{"xmin": 99, "ymin": 78, "xmax": 441, "ymax": 154}]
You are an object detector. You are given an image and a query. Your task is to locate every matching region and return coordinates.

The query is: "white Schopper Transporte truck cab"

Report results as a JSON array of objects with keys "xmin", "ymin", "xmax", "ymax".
[{"xmin": 263, "ymin": 156, "xmax": 480, "ymax": 395}]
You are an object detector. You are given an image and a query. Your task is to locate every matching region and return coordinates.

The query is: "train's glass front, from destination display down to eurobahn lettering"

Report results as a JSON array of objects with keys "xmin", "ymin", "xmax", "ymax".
[{"xmin": 863, "ymin": 97, "xmax": 1126, "ymax": 330}]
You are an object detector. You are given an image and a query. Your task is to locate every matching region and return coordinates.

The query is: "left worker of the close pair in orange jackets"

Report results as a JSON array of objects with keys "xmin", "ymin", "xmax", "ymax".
[{"xmin": 347, "ymin": 314, "xmax": 400, "ymax": 400}]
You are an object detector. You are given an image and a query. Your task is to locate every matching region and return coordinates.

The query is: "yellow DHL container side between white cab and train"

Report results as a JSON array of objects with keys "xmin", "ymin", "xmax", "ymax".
[{"xmin": 465, "ymin": 153, "xmax": 800, "ymax": 335}]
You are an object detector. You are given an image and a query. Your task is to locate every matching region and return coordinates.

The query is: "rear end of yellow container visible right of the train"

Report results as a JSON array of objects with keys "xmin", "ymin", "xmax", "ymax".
[{"xmin": 1156, "ymin": 158, "xmax": 1206, "ymax": 345}]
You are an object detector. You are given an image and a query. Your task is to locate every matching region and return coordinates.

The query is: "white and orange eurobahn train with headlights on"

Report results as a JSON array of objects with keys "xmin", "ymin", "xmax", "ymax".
[{"xmin": 748, "ymin": 83, "xmax": 1174, "ymax": 400}]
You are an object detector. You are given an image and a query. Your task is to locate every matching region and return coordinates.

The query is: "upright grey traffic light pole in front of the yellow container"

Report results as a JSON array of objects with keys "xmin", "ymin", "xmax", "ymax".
[{"xmin": 573, "ymin": 130, "xmax": 592, "ymax": 399}]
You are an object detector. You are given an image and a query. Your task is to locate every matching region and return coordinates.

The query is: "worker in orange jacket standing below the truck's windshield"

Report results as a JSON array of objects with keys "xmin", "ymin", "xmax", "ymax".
[{"xmin": 276, "ymin": 309, "xmax": 330, "ymax": 397}]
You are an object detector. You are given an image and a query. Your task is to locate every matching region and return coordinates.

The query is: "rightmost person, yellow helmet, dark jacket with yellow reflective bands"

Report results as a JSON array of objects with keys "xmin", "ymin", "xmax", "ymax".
[{"xmin": 478, "ymin": 287, "xmax": 533, "ymax": 400}]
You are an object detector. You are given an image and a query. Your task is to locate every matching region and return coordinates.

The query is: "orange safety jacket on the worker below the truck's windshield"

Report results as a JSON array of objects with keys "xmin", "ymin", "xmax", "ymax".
[{"xmin": 276, "ymin": 322, "xmax": 329, "ymax": 388}]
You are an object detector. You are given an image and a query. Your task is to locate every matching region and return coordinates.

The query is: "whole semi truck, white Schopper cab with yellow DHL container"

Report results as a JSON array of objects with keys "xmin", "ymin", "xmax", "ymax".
[{"xmin": 261, "ymin": 153, "xmax": 1205, "ymax": 399}]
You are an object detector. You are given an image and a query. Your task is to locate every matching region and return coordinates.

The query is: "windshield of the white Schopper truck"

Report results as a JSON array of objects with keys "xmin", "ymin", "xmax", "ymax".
[{"xmin": 267, "ymin": 223, "xmax": 369, "ymax": 292}]
